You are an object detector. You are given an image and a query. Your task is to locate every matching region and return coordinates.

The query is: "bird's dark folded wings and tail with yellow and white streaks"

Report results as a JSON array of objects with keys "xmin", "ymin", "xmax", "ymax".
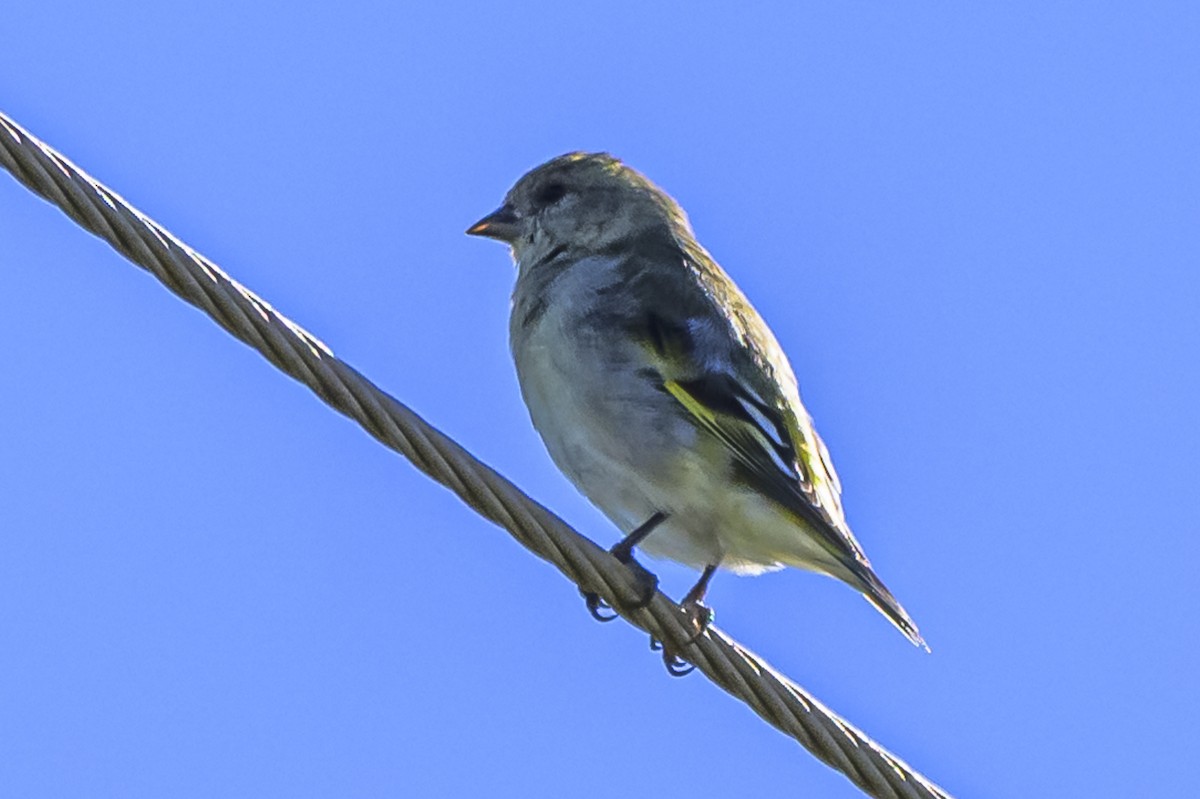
[{"xmin": 618, "ymin": 244, "xmax": 928, "ymax": 649}]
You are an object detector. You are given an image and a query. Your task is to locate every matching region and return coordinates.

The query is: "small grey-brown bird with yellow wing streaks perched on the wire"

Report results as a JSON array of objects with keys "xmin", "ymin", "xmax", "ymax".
[{"xmin": 467, "ymin": 152, "xmax": 928, "ymax": 672}]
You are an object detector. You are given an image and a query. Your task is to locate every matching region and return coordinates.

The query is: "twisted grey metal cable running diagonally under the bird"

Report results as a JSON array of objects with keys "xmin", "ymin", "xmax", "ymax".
[{"xmin": 0, "ymin": 113, "xmax": 949, "ymax": 799}]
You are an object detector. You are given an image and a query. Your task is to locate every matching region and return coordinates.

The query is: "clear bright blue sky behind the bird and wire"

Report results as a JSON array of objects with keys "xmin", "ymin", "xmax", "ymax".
[{"xmin": 0, "ymin": 0, "xmax": 1200, "ymax": 797}]
